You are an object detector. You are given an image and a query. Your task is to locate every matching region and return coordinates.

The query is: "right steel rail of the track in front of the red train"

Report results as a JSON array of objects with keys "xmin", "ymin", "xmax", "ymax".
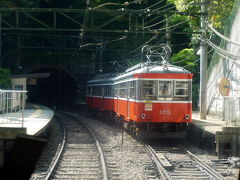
[{"xmin": 179, "ymin": 145, "xmax": 224, "ymax": 180}]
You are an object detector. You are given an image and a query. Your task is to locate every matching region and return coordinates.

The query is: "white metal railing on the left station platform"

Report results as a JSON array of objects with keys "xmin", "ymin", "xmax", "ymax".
[{"xmin": 0, "ymin": 89, "xmax": 27, "ymax": 127}]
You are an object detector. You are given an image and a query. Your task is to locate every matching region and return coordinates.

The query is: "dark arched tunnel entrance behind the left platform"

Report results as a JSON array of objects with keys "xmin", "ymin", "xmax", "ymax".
[{"xmin": 27, "ymin": 69, "xmax": 77, "ymax": 108}]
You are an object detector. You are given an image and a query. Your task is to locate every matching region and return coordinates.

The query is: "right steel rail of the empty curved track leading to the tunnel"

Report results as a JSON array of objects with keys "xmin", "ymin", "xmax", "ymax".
[{"xmin": 57, "ymin": 111, "xmax": 108, "ymax": 180}]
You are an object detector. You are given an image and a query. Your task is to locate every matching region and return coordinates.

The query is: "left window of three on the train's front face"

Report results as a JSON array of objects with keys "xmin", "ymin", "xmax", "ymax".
[{"xmin": 142, "ymin": 80, "xmax": 157, "ymax": 100}]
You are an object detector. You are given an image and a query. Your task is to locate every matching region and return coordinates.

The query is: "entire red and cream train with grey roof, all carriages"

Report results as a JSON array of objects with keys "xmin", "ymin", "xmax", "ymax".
[{"xmin": 87, "ymin": 62, "xmax": 192, "ymax": 138}]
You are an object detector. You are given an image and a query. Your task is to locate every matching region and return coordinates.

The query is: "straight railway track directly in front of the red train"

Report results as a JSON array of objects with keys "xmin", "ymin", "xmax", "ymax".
[{"xmin": 146, "ymin": 145, "xmax": 225, "ymax": 180}]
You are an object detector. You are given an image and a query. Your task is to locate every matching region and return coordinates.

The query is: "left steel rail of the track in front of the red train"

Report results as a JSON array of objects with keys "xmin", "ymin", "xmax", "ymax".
[{"xmin": 145, "ymin": 145, "xmax": 171, "ymax": 180}]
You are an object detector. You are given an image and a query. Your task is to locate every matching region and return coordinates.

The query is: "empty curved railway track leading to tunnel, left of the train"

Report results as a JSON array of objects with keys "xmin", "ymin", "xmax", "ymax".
[{"xmin": 45, "ymin": 114, "xmax": 108, "ymax": 180}]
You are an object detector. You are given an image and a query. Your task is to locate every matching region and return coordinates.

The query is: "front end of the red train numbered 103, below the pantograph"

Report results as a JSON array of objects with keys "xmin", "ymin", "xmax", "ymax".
[{"xmin": 134, "ymin": 65, "xmax": 192, "ymax": 138}]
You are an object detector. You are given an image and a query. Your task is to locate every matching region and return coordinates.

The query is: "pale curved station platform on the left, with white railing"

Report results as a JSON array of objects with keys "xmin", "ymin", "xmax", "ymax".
[{"xmin": 0, "ymin": 104, "xmax": 54, "ymax": 139}]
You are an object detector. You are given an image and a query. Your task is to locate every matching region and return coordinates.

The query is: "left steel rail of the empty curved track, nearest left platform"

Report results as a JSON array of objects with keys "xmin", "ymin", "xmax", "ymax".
[{"xmin": 45, "ymin": 117, "xmax": 67, "ymax": 180}]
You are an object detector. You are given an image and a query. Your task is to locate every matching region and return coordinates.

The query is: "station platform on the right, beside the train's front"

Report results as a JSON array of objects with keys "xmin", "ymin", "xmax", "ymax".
[{"xmin": 190, "ymin": 112, "xmax": 240, "ymax": 157}]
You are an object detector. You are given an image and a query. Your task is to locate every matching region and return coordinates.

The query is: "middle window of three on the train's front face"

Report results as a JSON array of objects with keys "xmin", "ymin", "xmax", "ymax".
[{"xmin": 158, "ymin": 81, "xmax": 172, "ymax": 98}]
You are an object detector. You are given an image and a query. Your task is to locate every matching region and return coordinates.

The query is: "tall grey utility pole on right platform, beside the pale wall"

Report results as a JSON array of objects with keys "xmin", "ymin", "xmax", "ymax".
[{"xmin": 200, "ymin": 0, "xmax": 208, "ymax": 119}]
